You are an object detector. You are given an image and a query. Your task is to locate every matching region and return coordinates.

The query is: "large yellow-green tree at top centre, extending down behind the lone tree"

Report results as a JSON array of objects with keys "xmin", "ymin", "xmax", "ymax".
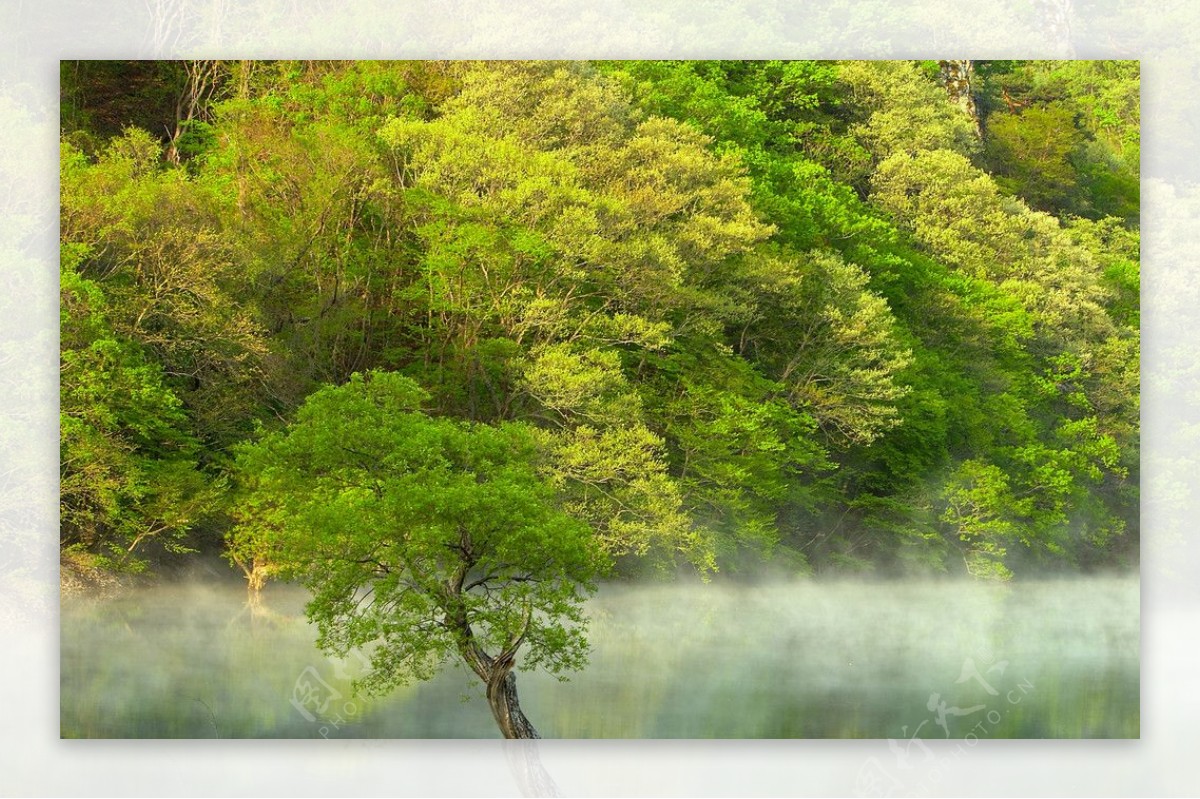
[{"xmin": 380, "ymin": 64, "xmax": 769, "ymax": 569}]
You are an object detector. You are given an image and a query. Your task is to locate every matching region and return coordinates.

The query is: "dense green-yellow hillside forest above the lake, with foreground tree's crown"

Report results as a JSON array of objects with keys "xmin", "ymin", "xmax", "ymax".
[{"xmin": 60, "ymin": 61, "xmax": 1140, "ymax": 585}]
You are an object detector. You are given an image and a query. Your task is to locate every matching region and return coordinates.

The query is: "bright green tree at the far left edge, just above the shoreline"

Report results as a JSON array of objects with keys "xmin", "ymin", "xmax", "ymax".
[{"xmin": 59, "ymin": 255, "xmax": 215, "ymax": 570}]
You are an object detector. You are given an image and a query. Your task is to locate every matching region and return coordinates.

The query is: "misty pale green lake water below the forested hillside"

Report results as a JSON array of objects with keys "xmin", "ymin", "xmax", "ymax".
[{"xmin": 61, "ymin": 577, "xmax": 1140, "ymax": 734}]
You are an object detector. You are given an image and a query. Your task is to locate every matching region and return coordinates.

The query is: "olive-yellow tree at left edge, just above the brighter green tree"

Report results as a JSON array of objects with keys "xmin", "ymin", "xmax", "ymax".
[{"xmin": 60, "ymin": 128, "xmax": 265, "ymax": 445}]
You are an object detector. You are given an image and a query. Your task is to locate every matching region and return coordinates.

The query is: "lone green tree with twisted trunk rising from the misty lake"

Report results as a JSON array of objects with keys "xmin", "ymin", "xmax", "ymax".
[{"xmin": 230, "ymin": 373, "xmax": 605, "ymax": 738}]
